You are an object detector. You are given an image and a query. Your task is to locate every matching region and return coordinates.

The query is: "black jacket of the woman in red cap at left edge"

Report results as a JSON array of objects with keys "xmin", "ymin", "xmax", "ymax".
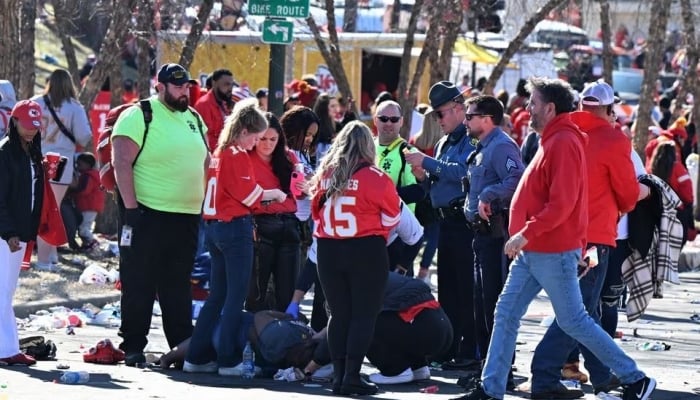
[{"xmin": 0, "ymin": 134, "xmax": 44, "ymax": 242}]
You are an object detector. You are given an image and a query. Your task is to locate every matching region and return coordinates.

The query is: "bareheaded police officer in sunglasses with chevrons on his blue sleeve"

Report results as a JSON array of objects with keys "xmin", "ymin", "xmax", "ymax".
[{"xmin": 464, "ymin": 96, "xmax": 524, "ymax": 368}]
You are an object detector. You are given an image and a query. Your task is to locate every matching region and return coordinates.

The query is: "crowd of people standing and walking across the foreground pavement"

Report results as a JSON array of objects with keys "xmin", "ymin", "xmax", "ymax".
[{"xmin": 0, "ymin": 55, "xmax": 695, "ymax": 400}]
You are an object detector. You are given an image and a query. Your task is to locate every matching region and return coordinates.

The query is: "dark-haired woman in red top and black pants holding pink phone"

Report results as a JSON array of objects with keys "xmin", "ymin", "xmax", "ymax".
[{"xmin": 246, "ymin": 112, "xmax": 301, "ymax": 312}]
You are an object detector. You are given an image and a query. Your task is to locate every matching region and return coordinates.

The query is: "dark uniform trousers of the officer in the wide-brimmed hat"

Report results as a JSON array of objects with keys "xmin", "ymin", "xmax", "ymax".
[{"xmin": 437, "ymin": 217, "xmax": 477, "ymax": 360}]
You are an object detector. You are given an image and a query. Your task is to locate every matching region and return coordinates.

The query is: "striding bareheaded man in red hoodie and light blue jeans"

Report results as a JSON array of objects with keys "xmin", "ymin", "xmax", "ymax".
[{"xmin": 461, "ymin": 78, "xmax": 656, "ymax": 400}]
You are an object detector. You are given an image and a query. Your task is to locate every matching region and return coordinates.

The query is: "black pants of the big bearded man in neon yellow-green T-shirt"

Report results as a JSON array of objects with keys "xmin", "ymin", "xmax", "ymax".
[{"xmin": 119, "ymin": 206, "xmax": 199, "ymax": 353}]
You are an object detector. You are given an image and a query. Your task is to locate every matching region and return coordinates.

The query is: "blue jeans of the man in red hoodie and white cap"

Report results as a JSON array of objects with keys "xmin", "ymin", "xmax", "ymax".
[{"xmin": 530, "ymin": 244, "xmax": 611, "ymax": 393}]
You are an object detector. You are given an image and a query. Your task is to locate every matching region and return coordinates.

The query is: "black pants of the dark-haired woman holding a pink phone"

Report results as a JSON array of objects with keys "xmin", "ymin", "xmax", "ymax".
[{"xmin": 246, "ymin": 214, "xmax": 301, "ymax": 312}]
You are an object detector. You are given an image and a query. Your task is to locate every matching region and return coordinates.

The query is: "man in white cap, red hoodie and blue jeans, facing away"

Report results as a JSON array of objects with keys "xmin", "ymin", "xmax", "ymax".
[{"xmin": 531, "ymin": 81, "xmax": 648, "ymax": 399}]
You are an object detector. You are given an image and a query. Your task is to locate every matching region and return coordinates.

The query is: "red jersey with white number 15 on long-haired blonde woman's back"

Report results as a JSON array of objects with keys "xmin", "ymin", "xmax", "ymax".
[{"xmin": 311, "ymin": 166, "xmax": 401, "ymax": 240}]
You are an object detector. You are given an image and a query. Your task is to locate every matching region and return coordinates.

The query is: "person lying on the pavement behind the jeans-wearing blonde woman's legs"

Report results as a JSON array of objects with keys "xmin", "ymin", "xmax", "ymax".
[{"xmin": 160, "ymin": 310, "xmax": 330, "ymax": 376}]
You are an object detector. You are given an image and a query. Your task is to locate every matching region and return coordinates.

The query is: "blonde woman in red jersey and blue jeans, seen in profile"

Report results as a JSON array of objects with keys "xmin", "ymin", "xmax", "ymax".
[{"xmin": 183, "ymin": 99, "xmax": 287, "ymax": 375}]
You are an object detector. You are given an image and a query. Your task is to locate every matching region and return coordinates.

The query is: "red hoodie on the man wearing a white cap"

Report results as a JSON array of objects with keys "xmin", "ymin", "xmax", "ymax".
[{"xmin": 571, "ymin": 111, "xmax": 639, "ymax": 247}]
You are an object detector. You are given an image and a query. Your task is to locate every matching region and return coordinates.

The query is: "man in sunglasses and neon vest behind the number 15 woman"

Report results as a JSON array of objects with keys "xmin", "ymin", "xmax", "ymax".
[{"xmin": 374, "ymin": 100, "xmax": 425, "ymax": 276}]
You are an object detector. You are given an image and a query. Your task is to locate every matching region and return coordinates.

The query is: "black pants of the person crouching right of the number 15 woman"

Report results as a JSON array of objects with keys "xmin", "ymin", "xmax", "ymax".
[{"xmin": 367, "ymin": 308, "xmax": 452, "ymax": 376}]
